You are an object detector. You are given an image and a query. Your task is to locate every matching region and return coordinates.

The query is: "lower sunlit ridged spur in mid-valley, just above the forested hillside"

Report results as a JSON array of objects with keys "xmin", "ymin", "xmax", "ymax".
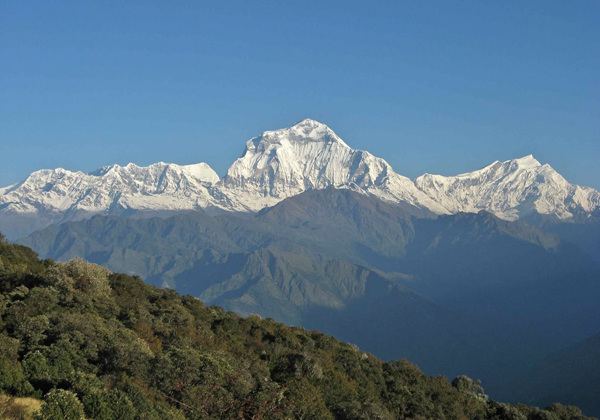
[{"xmin": 175, "ymin": 248, "xmax": 404, "ymax": 325}]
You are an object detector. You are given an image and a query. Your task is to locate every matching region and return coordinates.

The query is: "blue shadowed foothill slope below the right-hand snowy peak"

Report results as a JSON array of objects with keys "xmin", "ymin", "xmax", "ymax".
[{"xmin": 402, "ymin": 213, "xmax": 600, "ymax": 341}]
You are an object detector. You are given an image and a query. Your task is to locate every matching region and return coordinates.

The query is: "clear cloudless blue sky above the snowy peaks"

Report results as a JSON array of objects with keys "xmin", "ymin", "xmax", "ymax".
[{"xmin": 0, "ymin": 0, "xmax": 600, "ymax": 188}]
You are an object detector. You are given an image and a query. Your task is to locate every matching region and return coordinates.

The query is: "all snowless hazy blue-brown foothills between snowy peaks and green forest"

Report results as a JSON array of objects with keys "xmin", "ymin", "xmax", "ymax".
[{"xmin": 17, "ymin": 188, "xmax": 600, "ymax": 406}]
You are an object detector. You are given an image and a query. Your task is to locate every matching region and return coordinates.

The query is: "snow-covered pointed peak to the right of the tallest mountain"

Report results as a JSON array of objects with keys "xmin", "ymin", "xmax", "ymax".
[{"xmin": 415, "ymin": 155, "xmax": 600, "ymax": 221}]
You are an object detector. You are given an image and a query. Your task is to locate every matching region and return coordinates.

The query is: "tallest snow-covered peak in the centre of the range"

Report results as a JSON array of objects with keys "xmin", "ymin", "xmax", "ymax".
[{"xmin": 221, "ymin": 119, "xmax": 445, "ymax": 213}]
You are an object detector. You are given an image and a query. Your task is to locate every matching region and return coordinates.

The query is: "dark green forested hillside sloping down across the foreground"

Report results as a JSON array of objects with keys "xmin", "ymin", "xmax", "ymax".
[{"xmin": 0, "ymin": 233, "xmax": 586, "ymax": 420}]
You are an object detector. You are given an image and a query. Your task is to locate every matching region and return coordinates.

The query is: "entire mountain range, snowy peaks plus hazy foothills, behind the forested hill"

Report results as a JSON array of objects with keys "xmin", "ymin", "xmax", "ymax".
[{"xmin": 0, "ymin": 120, "xmax": 600, "ymax": 416}]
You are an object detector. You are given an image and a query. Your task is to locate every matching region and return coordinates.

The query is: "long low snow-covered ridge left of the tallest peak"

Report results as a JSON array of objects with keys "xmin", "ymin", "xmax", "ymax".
[{"xmin": 0, "ymin": 162, "xmax": 226, "ymax": 237}]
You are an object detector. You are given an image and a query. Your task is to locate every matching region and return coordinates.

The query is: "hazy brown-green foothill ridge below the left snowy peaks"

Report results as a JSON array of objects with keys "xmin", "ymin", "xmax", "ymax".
[{"xmin": 21, "ymin": 212, "xmax": 243, "ymax": 286}]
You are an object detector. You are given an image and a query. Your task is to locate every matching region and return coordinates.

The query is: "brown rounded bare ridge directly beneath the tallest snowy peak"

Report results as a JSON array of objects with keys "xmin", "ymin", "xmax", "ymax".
[{"xmin": 230, "ymin": 188, "xmax": 418, "ymax": 268}]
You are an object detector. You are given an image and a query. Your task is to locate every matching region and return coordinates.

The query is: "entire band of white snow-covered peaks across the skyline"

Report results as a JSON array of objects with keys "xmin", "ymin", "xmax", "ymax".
[{"xmin": 0, "ymin": 119, "xmax": 600, "ymax": 238}]
